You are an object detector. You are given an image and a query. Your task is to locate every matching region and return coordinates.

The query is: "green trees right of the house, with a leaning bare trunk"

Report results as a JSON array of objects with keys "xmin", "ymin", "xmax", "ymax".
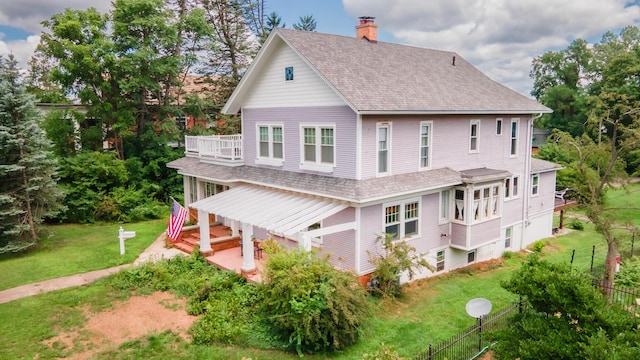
[{"xmin": 530, "ymin": 26, "xmax": 640, "ymax": 287}]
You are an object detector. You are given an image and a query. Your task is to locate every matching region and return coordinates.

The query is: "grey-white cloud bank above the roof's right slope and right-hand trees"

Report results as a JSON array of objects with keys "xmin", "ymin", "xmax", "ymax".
[{"xmin": 343, "ymin": 0, "xmax": 640, "ymax": 95}]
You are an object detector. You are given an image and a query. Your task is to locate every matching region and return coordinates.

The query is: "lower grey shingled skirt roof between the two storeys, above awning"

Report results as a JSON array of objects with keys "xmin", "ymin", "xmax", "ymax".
[{"xmin": 167, "ymin": 157, "xmax": 462, "ymax": 202}]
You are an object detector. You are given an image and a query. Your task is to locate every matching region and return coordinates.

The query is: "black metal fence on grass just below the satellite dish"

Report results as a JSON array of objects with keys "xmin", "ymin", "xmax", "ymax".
[{"xmin": 414, "ymin": 301, "xmax": 527, "ymax": 360}]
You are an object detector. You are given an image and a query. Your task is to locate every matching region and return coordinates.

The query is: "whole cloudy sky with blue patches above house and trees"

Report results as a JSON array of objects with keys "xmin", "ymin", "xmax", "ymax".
[{"xmin": 0, "ymin": 0, "xmax": 640, "ymax": 95}]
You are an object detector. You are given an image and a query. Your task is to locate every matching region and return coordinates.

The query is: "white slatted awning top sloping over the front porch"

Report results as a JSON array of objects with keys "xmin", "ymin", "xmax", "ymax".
[{"xmin": 189, "ymin": 185, "xmax": 349, "ymax": 236}]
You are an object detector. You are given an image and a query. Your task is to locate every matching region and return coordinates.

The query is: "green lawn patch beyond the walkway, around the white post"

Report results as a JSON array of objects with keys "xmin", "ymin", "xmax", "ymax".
[{"xmin": 0, "ymin": 220, "xmax": 166, "ymax": 290}]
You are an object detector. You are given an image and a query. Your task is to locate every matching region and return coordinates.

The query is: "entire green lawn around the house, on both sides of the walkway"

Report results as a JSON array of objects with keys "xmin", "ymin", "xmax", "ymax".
[{"xmin": 0, "ymin": 200, "xmax": 624, "ymax": 360}]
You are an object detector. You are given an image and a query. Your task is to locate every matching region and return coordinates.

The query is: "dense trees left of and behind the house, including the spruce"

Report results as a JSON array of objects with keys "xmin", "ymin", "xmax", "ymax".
[{"xmin": 0, "ymin": 0, "xmax": 316, "ymax": 253}]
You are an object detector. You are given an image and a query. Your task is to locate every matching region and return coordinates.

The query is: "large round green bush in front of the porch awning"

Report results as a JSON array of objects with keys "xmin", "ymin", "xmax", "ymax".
[{"xmin": 259, "ymin": 250, "xmax": 369, "ymax": 354}]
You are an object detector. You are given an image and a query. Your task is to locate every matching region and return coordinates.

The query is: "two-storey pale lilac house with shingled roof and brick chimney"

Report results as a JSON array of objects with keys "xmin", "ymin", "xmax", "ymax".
[{"xmin": 168, "ymin": 18, "xmax": 559, "ymax": 282}]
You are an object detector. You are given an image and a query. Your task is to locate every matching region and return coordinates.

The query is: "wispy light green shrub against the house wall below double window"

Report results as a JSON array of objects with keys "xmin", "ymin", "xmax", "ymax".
[{"xmin": 368, "ymin": 234, "xmax": 435, "ymax": 297}]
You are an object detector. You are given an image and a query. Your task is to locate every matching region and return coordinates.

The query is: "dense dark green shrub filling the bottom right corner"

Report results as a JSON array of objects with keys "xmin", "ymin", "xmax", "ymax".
[{"xmin": 492, "ymin": 254, "xmax": 640, "ymax": 360}]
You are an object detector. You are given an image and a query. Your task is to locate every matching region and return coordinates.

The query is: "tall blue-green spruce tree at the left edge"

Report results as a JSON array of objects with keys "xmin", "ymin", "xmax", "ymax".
[{"xmin": 0, "ymin": 57, "xmax": 63, "ymax": 253}]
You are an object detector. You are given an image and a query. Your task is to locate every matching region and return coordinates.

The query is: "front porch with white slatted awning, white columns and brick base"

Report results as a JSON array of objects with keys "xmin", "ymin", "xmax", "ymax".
[{"xmin": 189, "ymin": 185, "xmax": 356, "ymax": 278}]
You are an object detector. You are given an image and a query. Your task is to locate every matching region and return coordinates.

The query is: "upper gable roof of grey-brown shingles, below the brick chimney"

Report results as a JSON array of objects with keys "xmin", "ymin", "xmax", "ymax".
[{"xmin": 223, "ymin": 28, "xmax": 551, "ymax": 114}]
